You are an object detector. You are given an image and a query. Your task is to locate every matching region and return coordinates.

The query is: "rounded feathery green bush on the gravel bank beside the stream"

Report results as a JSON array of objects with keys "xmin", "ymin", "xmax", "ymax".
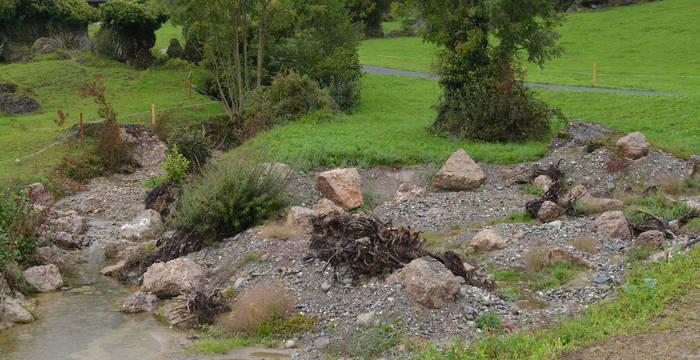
[{"xmin": 175, "ymin": 159, "xmax": 289, "ymax": 236}]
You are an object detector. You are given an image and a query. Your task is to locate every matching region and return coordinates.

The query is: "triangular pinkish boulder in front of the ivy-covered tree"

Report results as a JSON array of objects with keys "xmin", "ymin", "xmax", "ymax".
[{"xmin": 432, "ymin": 149, "xmax": 486, "ymax": 191}]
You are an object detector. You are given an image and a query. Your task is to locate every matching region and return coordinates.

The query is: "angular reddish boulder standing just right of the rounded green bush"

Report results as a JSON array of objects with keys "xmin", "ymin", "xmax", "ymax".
[{"xmin": 316, "ymin": 168, "xmax": 364, "ymax": 211}]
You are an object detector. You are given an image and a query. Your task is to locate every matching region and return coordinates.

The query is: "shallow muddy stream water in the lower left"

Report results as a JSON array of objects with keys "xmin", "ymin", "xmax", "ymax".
[{"xmin": 0, "ymin": 219, "xmax": 182, "ymax": 360}]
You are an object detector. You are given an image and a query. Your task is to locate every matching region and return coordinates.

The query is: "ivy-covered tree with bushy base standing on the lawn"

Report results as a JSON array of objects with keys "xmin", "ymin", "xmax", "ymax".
[{"xmin": 409, "ymin": 0, "xmax": 563, "ymax": 141}]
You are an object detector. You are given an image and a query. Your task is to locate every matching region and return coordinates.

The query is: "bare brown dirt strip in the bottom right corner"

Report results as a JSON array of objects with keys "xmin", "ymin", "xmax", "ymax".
[{"xmin": 559, "ymin": 290, "xmax": 700, "ymax": 360}]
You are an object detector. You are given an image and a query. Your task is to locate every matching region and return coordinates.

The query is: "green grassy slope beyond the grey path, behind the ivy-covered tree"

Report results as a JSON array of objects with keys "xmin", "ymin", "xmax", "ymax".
[{"xmin": 360, "ymin": 0, "xmax": 700, "ymax": 94}]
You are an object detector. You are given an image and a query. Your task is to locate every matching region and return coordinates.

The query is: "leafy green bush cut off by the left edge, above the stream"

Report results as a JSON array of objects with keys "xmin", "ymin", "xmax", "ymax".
[{"xmin": 0, "ymin": 189, "xmax": 42, "ymax": 268}]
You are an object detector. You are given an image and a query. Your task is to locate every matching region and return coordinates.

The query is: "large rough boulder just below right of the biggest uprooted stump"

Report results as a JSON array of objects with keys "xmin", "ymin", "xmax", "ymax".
[{"xmin": 387, "ymin": 256, "xmax": 459, "ymax": 309}]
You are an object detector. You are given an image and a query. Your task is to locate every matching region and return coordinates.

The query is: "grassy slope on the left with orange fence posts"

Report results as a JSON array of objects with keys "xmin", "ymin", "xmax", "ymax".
[{"xmin": 0, "ymin": 58, "xmax": 219, "ymax": 181}]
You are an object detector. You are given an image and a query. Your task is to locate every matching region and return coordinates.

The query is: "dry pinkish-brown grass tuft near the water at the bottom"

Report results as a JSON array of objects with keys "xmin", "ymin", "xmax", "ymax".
[{"xmin": 221, "ymin": 284, "xmax": 294, "ymax": 335}]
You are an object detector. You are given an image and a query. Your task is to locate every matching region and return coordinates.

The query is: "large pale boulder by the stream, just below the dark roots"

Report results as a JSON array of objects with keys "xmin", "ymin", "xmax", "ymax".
[{"xmin": 141, "ymin": 258, "xmax": 206, "ymax": 298}]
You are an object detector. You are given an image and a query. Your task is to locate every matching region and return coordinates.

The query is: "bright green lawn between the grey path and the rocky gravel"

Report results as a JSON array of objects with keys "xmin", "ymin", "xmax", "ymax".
[{"xmin": 227, "ymin": 74, "xmax": 700, "ymax": 166}]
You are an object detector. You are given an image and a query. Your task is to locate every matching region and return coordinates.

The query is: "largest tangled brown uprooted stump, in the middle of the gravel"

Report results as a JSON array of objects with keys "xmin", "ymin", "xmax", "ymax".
[{"xmin": 310, "ymin": 213, "xmax": 496, "ymax": 290}]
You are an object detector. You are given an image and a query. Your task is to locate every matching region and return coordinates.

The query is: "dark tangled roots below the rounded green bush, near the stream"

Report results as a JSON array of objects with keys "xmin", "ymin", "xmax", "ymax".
[{"xmin": 117, "ymin": 228, "xmax": 208, "ymax": 282}]
